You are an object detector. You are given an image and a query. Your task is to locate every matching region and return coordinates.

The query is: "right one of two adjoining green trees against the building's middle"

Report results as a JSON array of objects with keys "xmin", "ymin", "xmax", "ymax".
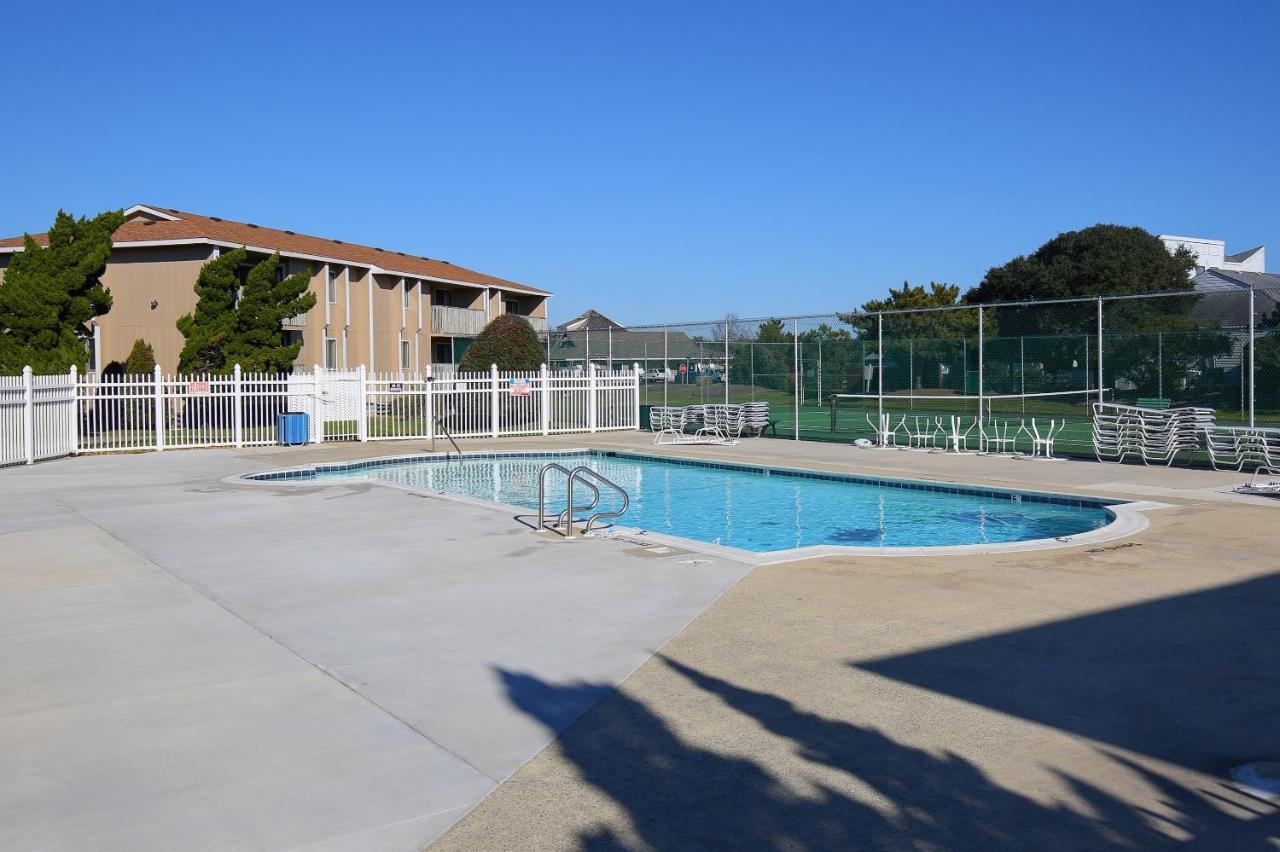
[{"xmin": 227, "ymin": 253, "xmax": 316, "ymax": 372}]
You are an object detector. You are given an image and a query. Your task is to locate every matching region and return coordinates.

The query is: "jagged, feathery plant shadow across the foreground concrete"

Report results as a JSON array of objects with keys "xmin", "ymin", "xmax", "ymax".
[{"xmin": 499, "ymin": 658, "xmax": 1276, "ymax": 852}]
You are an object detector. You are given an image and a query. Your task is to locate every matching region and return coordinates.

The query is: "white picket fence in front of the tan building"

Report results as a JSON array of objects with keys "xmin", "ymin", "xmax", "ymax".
[{"xmin": 0, "ymin": 365, "xmax": 640, "ymax": 466}]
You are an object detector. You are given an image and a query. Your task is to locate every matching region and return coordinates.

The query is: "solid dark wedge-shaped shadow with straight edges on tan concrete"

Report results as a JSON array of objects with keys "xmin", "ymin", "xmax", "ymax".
[{"xmin": 850, "ymin": 574, "xmax": 1280, "ymax": 774}]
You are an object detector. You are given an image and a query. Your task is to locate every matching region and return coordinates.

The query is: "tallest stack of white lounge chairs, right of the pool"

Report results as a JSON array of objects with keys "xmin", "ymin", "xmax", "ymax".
[{"xmin": 1093, "ymin": 403, "xmax": 1213, "ymax": 464}]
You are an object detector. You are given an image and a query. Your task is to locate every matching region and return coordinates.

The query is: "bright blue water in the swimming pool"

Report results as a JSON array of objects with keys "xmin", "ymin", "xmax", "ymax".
[{"xmin": 264, "ymin": 452, "xmax": 1112, "ymax": 553}]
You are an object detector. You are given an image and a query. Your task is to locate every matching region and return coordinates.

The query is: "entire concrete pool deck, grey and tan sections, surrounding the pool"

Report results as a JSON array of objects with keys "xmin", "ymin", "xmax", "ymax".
[{"xmin": 0, "ymin": 432, "xmax": 1280, "ymax": 849}]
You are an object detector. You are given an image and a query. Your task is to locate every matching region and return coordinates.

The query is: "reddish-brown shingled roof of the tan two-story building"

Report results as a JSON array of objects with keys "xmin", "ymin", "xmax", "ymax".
[{"xmin": 0, "ymin": 205, "xmax": 550, "ymax": 296}]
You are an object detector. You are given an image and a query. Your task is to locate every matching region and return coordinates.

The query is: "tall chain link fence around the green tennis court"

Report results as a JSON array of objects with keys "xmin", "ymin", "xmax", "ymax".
[{"xmin": 543, "ymin": 287, "xmax": 1280, "ymax": 455}]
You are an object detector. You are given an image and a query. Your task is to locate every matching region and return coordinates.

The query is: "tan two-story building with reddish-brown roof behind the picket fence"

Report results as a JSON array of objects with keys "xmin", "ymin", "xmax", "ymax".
[{"xmin": 0, "ymin": 205, "xmax": 550, "ymax": 372}]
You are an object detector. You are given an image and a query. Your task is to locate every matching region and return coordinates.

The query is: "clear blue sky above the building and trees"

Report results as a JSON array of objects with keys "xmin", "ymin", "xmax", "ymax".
[{"xmin": 0, "ymin": 0, "xmax": 1280, "ymax": 322}]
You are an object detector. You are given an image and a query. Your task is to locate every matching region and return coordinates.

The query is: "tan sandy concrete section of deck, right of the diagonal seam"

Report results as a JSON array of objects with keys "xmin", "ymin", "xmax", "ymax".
[{"xmin": 433, "ymin": 441, "xmax": 1280, "ymax": 851}]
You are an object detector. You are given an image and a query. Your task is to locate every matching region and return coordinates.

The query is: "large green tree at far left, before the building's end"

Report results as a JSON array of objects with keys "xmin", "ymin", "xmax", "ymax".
[{"xmin": 0, "ymin": 210, "xmax": 124, "ymax": 374}]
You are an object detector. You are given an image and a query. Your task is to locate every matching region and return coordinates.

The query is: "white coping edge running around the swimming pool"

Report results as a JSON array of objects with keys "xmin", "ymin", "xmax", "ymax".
[{"xmin": 223, "ymin": 446, "xmax": 1169, "ymax": 565}]
